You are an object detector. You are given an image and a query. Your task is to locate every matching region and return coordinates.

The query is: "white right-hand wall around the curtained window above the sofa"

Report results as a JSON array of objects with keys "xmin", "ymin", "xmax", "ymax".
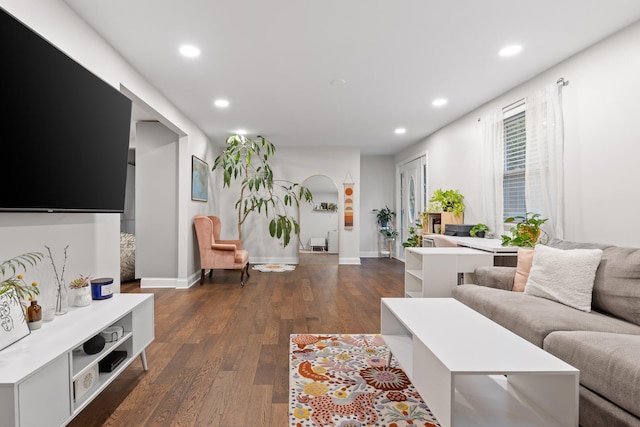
[{"xmin": 396, "ymin": 19, "xmax": 640, "ymax": 246}]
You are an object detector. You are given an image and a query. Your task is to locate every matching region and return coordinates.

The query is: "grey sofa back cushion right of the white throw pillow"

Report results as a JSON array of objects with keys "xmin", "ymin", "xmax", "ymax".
[{"xmin": 592, "ymin": 246, "xmax": 640, "ymax": 325}]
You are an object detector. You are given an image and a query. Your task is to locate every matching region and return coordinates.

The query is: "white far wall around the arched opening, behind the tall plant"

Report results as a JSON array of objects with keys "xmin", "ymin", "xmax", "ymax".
[{"xmin": 219, "ymin": 145, "xmax": 361, "ymax": 264}]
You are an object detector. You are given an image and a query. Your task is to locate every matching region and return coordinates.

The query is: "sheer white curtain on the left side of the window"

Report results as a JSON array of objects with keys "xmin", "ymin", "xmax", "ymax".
[{"xmin": 480, "ymin": 110, "xmax": 504, "ymax": 237}]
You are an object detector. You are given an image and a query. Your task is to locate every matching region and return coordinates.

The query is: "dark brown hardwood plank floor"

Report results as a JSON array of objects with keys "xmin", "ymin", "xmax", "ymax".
[{"xmin": 70, "ymin": 258, "xmax": 404, "ymax": 427}]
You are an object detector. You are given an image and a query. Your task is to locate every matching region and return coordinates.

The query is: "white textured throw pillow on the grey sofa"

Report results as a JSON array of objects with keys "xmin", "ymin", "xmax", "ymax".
[{"xmin": 524, "ymin": 245, "xmax": 602, "ymax": 312}]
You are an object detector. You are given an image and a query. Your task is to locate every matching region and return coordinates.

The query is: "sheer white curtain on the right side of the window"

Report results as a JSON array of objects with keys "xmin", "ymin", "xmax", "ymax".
[{"xmin": 525, "ymin": 84, "xmax": 564, "ymax": 238}]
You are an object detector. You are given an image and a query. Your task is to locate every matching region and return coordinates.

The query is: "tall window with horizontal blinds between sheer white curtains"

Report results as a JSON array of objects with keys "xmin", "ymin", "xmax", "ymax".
[{"xmin": 502, "ymin": 108, "xmax": 527, "ymax": 219}]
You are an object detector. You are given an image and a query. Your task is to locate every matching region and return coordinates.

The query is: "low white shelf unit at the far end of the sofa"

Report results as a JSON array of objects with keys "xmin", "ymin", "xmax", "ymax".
[{"xmin": 404, "ymin": 247, "xmax": 493, "ymax": 297}]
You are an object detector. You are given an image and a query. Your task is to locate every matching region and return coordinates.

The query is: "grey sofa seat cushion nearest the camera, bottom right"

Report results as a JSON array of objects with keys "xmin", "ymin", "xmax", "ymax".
[{"xmin": 543, "ymin": 331, "xmax": 640, "ymax": 417}]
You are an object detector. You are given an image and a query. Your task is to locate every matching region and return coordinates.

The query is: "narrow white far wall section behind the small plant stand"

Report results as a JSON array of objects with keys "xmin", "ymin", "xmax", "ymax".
[{"xmin": 360, "ymin": 156, "xmax": 399, "ymax": 258}]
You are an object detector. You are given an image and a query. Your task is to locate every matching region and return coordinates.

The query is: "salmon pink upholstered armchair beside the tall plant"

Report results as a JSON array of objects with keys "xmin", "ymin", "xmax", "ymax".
[{"xmin": 193, "ymin": 215, "xmax": 249, "ymax": 286}]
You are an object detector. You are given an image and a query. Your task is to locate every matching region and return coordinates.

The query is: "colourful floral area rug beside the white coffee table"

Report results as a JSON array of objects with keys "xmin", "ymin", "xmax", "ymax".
[{"xmin": 289, "ymin": 334, "xmax": 440, "ymax": 427}]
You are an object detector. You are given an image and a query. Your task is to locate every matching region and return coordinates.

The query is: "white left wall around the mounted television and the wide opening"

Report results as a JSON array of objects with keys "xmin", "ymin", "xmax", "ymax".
[{"xmin": 0, "ymin": 0, "xmax": 216, "ymax": 289}]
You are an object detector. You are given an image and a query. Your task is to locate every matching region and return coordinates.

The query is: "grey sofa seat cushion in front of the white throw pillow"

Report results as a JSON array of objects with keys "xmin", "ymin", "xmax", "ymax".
[{"xmin": 453, "ymin": 285, "xmax": 640, "ymax": 347}]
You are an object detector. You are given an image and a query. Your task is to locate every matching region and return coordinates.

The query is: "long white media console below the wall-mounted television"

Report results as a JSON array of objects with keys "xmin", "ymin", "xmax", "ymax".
[{"xmin": 0, "ymin": 294, "xmax": 154, "ymax": 427}]
